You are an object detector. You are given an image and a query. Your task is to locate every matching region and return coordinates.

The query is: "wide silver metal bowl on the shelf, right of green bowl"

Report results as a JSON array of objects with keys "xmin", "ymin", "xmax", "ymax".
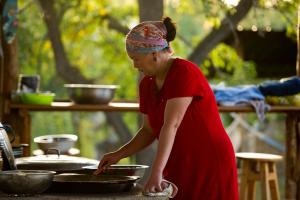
[{"xmin": 64, "ymin": 84, "xmax": 118, "ymax": 104}]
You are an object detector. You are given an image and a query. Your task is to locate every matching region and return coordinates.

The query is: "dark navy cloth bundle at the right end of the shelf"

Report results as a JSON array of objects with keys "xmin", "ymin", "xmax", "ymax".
[{"xmin": 258, "ymin": 76, "xmax": 300, "ymax": 96}]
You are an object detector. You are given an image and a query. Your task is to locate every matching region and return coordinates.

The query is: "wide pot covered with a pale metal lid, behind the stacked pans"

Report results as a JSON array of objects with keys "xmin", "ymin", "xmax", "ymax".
[{"xmin": 16, "ymin": 154, "xmax": 99, "ymax": 173}]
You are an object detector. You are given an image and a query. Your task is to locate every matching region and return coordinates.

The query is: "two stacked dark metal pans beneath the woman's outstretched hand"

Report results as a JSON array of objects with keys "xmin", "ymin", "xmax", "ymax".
[{"xmin": 50, "ymin": 165, "xmax": 148, "ymax": 193}]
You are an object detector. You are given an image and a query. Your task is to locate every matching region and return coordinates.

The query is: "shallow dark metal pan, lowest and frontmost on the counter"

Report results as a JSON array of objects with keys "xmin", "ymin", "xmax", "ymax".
[{"xmin": 48, "ymin": 173, "xmax": 139, "ymax": 193}]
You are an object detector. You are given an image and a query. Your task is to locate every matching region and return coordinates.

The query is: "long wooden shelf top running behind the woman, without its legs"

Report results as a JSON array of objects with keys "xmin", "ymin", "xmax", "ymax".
[{"xmin": 9, "ymin": 102, "xmax": 300, "ymax": 113}]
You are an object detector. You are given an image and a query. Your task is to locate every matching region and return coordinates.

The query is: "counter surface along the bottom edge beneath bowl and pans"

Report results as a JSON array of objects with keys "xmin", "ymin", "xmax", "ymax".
[{"xmin": 0, "ymin": 187, "xmax": 169, "ymax": 200}]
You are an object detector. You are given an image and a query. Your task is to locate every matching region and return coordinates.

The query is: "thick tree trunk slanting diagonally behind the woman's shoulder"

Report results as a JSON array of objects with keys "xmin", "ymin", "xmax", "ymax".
[{"xmin": 188, "ymin": 0, "xmax": 256, "ymax": 65}]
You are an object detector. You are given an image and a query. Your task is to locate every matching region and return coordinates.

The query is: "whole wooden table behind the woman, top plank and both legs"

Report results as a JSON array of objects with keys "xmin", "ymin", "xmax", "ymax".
[{"xmin": 6, "ymin": 102, "xmax": 300, "ymax": 200}]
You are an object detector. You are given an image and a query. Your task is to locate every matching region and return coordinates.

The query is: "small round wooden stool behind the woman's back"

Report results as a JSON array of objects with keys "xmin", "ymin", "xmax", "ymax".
[{"xmin": 235, "ymin": 153, "xmax": 282, "ymax": 200}]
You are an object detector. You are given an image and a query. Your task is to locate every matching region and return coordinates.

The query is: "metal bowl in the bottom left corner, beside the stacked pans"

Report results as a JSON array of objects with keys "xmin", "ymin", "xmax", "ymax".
[{"xmin": 0, "ymin": 170, "xmax": 55, "ymax": 195}]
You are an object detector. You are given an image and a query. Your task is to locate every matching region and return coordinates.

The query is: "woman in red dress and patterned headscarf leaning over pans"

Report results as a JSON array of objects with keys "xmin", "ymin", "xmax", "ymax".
[{"xmin": 95, "ymin": 18, "xmax": 238, "ymax": 200}]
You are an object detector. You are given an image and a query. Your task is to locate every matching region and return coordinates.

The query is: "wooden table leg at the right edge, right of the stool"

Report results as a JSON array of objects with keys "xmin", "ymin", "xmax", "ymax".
[{"xmin": 285, "ymin": 113, "xmax": 300, "ymax": 200}]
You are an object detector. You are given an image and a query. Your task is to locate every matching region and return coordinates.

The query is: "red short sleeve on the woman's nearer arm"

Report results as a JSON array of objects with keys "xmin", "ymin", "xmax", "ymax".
[{"xmin": 166, "ymin": 60, "xmax": 206, "ymax": 99}]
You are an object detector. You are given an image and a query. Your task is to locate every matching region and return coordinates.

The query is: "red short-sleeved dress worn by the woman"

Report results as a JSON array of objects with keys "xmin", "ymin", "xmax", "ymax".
[{"xmin": 140, "ymin": 58, "xmax": 238, "ymax": 200}]
